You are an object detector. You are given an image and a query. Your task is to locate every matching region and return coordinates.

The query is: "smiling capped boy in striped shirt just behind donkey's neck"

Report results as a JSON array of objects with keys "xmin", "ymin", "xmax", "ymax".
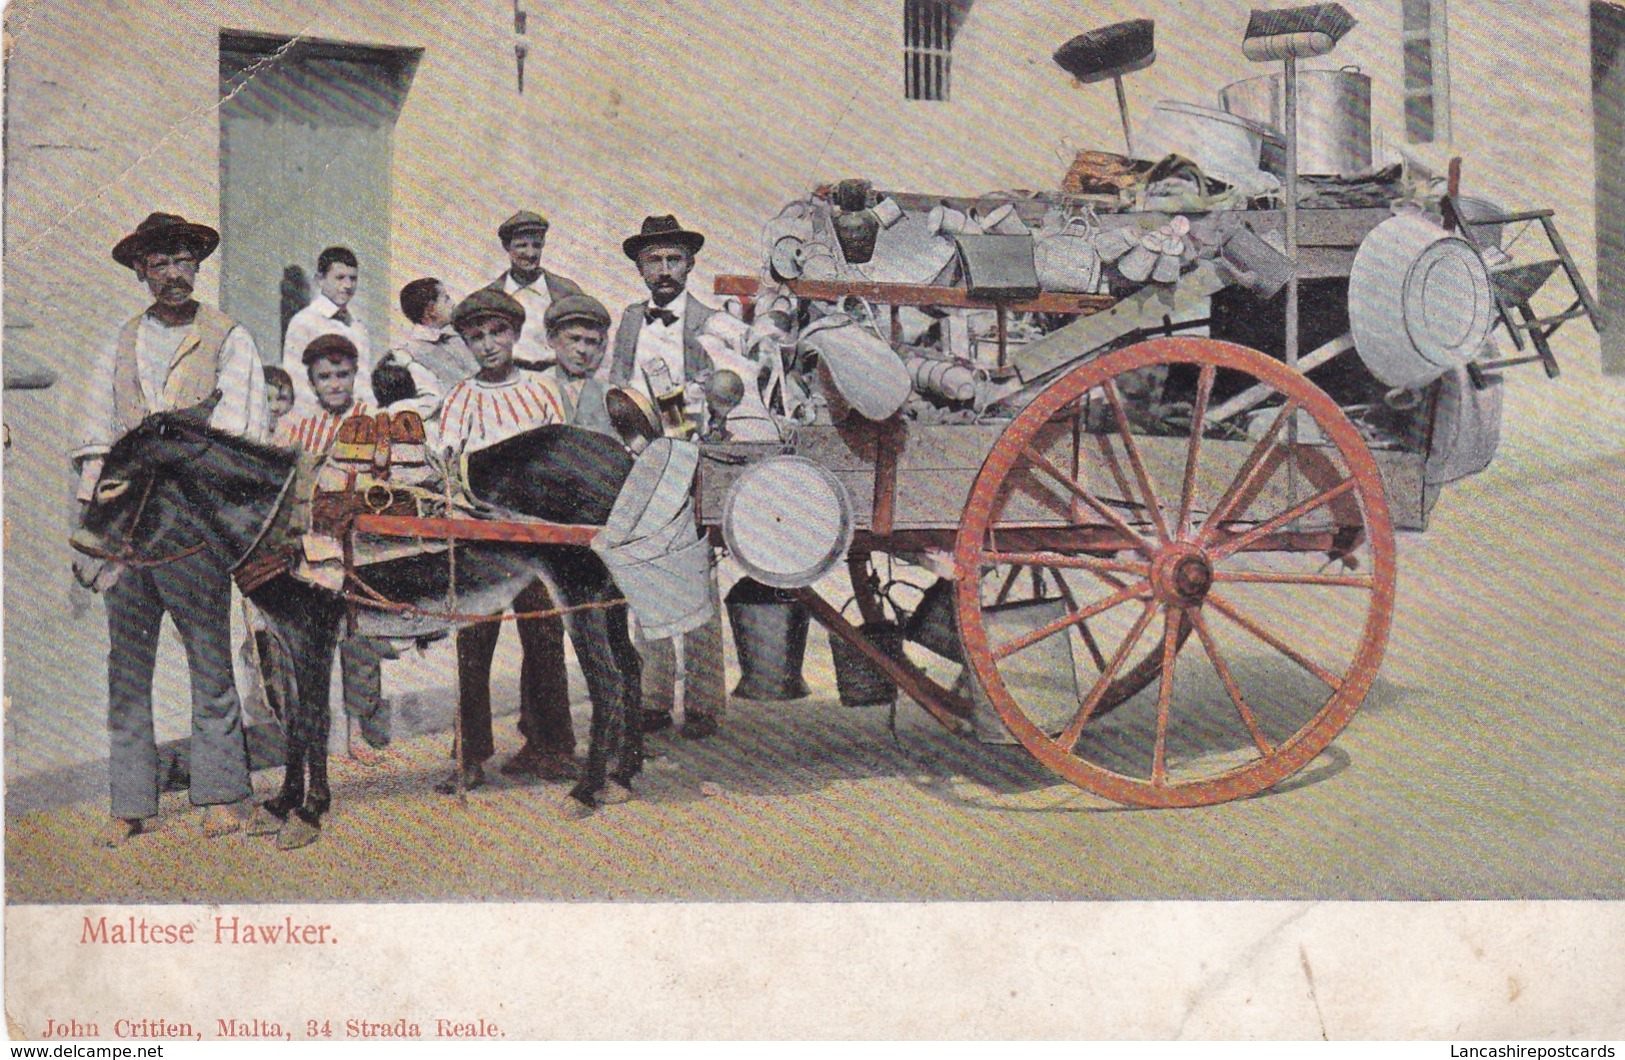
[{"xmin": 273, "ymin": 335, "xmax": 390, "ymax": 748}]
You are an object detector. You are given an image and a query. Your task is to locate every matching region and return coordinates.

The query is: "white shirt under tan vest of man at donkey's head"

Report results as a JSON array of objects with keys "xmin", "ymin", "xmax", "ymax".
[{"xmin": 72, "ymin": 311, "xmax": 270, "ymax": 501}]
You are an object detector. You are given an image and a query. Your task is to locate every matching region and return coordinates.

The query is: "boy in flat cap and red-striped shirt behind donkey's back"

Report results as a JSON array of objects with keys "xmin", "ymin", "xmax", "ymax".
[{"xmin": 436, "ymin": 288, "xmax": 579, "ymax": 793}]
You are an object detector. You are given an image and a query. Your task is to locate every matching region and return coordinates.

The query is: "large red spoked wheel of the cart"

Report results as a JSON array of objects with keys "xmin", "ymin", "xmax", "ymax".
[{"xmin": 954, "ymin": 338, "xmax": 1394, "ymax": 806}]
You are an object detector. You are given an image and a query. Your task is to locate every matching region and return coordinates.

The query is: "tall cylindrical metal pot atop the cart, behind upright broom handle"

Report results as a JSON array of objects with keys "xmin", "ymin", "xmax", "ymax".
[{"xmin": 1219, "ymin": 67, "xmax": 1372, "ymax": 177}]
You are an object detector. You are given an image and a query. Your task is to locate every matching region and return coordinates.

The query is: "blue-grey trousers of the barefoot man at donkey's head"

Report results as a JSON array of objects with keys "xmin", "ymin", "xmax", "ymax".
[{"xmin": 106, "ymin": 553, "xmax": 249, "ymax": 818}]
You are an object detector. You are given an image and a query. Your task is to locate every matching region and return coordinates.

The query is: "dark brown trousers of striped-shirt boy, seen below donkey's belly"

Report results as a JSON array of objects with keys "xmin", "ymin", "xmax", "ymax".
[{"xmin": 457, "ymin": 582, "xmax": 575, "ymax": 762}]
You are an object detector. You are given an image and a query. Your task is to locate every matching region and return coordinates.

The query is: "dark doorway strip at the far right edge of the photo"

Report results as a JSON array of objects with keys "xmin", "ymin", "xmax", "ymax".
[{"xmin": 1591, "ymin": 3, "xmax": 1625, "ymax": 376}]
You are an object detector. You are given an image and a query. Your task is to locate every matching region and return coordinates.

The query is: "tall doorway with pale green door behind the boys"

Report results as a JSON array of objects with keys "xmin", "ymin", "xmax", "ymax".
[{"xmin": 219, "ymin": 31, "xmax": 423, "ymax": 364}]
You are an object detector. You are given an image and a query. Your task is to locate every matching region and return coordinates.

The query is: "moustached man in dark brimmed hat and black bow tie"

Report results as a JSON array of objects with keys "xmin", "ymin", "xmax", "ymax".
[{"xmin": 609, "ymin": 215, "xmax": 728, "ymax": 740}]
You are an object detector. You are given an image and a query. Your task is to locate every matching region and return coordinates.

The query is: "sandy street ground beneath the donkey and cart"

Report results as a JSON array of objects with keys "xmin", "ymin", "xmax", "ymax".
[{"xmin": 5, "ymin": 438, "xmax": 1625, "ymax": 902}]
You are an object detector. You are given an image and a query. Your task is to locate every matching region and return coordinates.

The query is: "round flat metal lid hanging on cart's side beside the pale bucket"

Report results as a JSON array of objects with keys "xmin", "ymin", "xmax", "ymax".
[{"xmin": 722, "ymin": 457, "xmax": 855, "ymax": 589}]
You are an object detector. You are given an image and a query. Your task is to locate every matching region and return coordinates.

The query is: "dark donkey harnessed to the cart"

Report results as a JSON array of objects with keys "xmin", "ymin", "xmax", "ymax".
[{"xmin": 72, "ymin": 406, "xmax": 642, "ymax": 849}]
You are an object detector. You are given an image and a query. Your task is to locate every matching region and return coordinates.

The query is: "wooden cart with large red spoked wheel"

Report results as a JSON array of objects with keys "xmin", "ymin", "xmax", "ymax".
[{"xmin": 699, "ymin": 198, "xmax": 1599, "ymax": 806}]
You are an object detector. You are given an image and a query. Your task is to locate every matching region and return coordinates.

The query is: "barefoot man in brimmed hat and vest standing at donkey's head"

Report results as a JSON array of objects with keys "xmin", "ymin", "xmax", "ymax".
[{"xmin": 73, "ymin": 213, "xmax": 267, "ymax": 845}]
